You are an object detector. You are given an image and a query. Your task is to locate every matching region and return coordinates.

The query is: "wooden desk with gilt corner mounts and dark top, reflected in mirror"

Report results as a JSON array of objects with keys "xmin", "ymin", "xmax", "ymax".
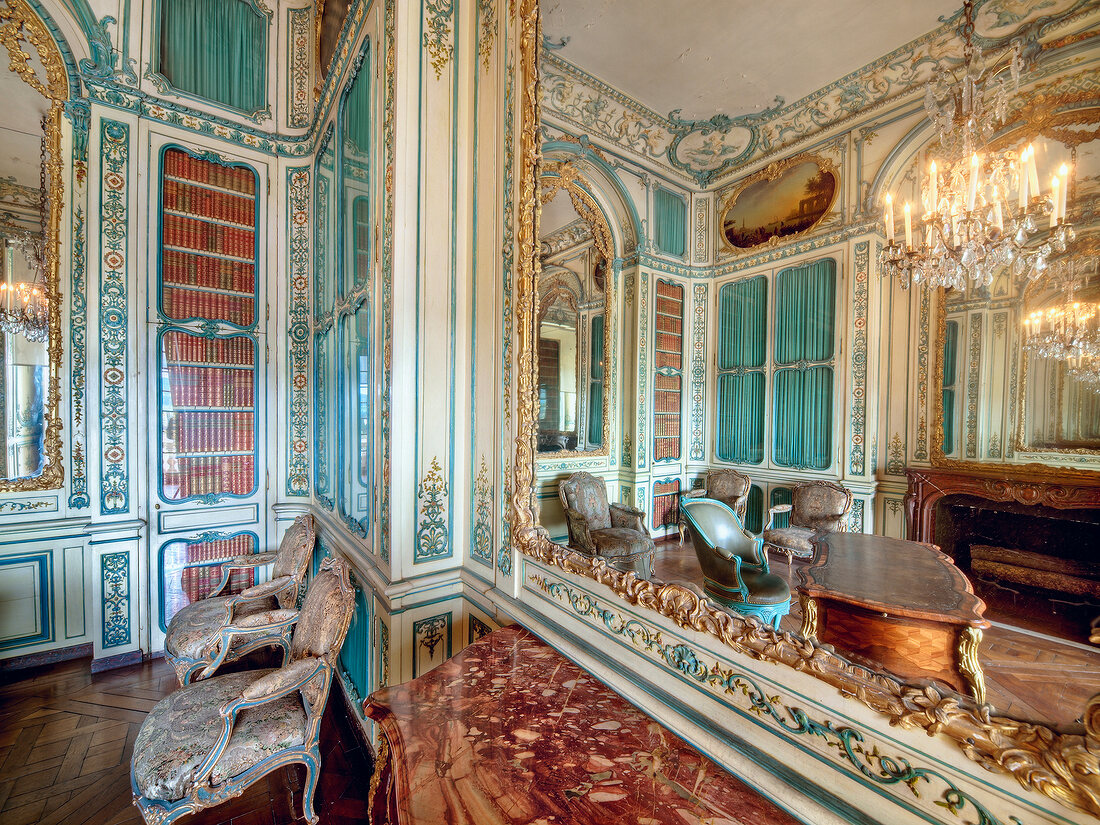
[{"xmin": 798, "ymin": 532, "xmax": 989, "ymax": 704}]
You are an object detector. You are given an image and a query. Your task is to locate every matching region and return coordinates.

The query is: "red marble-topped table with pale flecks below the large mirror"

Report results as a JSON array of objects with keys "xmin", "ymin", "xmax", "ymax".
[{"xmin": 364, "ymin": 626, "xmax": 798, "ymax": 825}]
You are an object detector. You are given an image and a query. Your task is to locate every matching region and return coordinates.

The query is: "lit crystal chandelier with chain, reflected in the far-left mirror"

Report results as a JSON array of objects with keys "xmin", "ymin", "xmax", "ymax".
[{"xmin": 0, "ymin": 118, "xmax": 50, "ymax": 343}]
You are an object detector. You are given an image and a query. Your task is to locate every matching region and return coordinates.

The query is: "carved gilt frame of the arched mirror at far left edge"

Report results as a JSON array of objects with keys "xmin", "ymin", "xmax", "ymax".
[{"xmin": 0, "ymin": 0, "xmax": 68, "ymax": 493}]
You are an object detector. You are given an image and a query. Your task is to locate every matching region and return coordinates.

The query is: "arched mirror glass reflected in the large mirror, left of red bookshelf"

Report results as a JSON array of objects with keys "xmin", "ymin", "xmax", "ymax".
[{"xmin": 537, "ymin": 189, "xmax": 607, "ymax": 453}]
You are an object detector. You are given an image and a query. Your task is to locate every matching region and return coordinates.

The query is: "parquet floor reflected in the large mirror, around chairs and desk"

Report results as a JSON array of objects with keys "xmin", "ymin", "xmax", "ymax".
[{"xmin": 653, "ymin": 540, "xmax": 1100, "ymax": 728}]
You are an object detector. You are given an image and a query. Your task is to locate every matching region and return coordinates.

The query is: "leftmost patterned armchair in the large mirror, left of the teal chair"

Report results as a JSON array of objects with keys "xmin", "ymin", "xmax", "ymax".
[{"xmin": 558, "ymin": 473, "xmax": 653, "ymax": 579}]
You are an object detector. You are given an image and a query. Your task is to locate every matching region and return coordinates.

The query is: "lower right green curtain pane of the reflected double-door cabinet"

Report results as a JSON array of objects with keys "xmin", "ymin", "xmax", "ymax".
[{"xmin": 772, "ymin": 366, "xmax": 833, "ymax": 470}]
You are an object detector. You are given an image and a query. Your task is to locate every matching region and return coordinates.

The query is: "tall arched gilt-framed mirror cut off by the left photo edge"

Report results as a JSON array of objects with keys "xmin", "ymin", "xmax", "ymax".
[{"xmin": 0, "ymin": 0, "xmax": 68, "ymax": 492}]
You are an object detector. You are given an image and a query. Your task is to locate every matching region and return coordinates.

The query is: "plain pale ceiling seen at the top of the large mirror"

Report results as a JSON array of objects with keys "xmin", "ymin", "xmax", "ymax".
[{"xmin": 542, "ymin": 0, "xmax": 960, "ymax": 120}]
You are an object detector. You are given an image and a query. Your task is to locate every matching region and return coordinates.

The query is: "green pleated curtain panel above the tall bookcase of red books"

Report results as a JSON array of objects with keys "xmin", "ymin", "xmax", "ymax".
[{"xmin": 160, "ymin": 0, "xmax": 267, "ymax": 112}]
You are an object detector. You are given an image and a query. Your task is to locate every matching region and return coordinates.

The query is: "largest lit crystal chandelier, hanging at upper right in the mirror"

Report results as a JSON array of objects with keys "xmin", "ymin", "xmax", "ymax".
[{"xmin": 879, "ymin": 0, "xmax": 1075, "ymax": 289}]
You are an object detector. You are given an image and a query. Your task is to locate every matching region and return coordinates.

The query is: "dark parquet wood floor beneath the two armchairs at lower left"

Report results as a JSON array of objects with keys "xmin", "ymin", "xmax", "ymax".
[{"xmin": 0, "ymin": 659, "xmax": 371, "ymax": 825}]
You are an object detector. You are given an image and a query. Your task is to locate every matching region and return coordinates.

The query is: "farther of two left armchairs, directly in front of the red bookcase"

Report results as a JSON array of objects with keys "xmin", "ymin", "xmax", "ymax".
[{"xmin": 164, "ymin": 516, "xmax": 317, "ymax": 685}]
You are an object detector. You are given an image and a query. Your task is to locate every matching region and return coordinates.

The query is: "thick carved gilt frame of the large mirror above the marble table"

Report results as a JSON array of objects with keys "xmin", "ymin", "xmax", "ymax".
[{"xmin": 510, "ymin": 0, "xmax": 1100, "ymax": 816}]
